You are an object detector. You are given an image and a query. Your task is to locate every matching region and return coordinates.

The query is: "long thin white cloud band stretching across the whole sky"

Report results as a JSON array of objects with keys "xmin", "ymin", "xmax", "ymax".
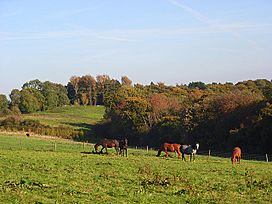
[{"xmin": 0, "ymin": 23, "xmax": 272, "ymax": 43}]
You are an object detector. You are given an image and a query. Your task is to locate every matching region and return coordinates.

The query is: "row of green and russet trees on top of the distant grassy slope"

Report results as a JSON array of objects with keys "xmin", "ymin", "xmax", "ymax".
[{"xmin": 0, "ymin": 75, "xmax": 132, "ymax": 115}]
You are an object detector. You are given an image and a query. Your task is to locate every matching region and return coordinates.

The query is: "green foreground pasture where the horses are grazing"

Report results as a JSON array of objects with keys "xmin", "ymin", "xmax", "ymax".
[{"xmin": 0, "ymin": 134, "xmax": 272, "ymax": 203}]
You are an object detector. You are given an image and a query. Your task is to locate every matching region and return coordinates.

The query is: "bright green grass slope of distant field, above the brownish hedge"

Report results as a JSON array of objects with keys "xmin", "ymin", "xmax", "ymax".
[{"xmin": 22, "ymin": 106, "xmax": 105, "ymax": 130}]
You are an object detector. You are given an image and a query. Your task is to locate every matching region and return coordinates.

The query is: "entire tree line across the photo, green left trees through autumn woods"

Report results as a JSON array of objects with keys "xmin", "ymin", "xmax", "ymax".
[{"xmin": 0, "ymin": 75, "xmax": 272, "ymax": 153}]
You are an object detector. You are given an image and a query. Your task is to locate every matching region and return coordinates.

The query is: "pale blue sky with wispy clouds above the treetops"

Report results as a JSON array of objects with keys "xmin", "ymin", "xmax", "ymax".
[{"xmin": 0, "ymin": 0, "xmax": 272, "ymax": 95}]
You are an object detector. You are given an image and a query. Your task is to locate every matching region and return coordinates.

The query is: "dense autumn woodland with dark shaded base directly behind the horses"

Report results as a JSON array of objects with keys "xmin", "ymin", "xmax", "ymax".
[{"xmin": 98, "ymin": 79, "xmax": 272, "ymax": 153}]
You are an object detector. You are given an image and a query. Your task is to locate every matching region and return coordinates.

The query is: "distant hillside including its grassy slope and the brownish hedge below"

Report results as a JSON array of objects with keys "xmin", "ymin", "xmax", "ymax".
[{"xmin": 0, "ymin": 106, "xmax": 105, "ymax": 139}]
